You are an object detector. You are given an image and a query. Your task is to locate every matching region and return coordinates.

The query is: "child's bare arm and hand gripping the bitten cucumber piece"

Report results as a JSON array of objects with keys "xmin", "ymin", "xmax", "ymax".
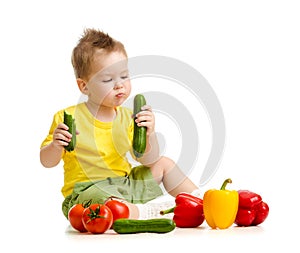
[{"xmin": 40, "ymin": 123, "xmax": 72, "ymax": 168}]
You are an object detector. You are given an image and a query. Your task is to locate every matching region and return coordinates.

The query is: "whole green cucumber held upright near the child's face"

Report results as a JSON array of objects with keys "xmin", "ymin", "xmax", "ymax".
[{"xmin": 132, "ymin": 94, "xmax": 147, "ymax": 158}]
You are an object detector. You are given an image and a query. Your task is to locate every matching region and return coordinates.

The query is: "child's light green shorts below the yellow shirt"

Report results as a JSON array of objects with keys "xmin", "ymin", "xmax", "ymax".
[{"xmin": 62, "ymin": 165, "xmax": 163, "ymax": 218}]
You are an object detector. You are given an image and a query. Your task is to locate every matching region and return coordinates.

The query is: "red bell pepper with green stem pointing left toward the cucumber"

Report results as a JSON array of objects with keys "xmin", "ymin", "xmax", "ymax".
[{"xmin": 160, "ymin": 193, "xmax": 204, "ymax": 228}]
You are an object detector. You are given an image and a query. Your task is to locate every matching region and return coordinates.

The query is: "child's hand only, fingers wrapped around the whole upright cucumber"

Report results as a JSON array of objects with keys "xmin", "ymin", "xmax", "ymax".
[{"xmin": 135, "ymin": 105, "xmax": 155, "ymax": 135}]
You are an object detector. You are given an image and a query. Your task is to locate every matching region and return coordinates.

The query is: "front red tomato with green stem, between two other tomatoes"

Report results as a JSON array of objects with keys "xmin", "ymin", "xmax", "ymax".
[{"xmin": 82, "ymin": 204, "xmax": 113, "ymax": 234}]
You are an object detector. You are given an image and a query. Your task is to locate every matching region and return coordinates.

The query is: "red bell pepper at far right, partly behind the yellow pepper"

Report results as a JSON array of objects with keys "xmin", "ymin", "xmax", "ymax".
[{"xmin": 234, "ymin": 190, "xmax": 269, "ymax": 226}]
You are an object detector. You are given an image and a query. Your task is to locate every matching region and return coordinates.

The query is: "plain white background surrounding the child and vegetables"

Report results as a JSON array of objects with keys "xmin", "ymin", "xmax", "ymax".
[{"xmin": 0, "ymin": 0, "xmax": 300, "ymax": 252}]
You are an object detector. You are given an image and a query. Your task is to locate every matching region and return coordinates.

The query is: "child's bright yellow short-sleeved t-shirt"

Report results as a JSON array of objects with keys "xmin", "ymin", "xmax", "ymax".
[{"xmin": 41, "ymin": 103, "xmax": 133, "ymax": 197}]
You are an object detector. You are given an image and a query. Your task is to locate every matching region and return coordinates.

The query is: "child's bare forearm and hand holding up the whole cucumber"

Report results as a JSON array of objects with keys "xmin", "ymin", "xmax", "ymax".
[{"xmin": 135, "ymin": 105, "xmax": 159, "ymax": 166}]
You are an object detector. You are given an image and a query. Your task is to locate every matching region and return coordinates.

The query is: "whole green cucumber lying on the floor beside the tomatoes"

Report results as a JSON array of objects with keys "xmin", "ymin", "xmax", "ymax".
[{"xmin": 113, "ymin": 218, "xmax": 176, "ymax": 234}]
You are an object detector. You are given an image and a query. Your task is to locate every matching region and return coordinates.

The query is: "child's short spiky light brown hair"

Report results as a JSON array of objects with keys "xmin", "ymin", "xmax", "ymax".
[{"xmin": 72, "ymin": 28, "xmax": 127, "ymax": 78}]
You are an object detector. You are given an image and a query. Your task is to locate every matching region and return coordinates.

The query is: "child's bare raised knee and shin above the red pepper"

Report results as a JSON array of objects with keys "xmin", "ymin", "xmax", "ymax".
[{"xmin": 150, "ymin": 157, "xmax": 198, "ymax": 197}]
